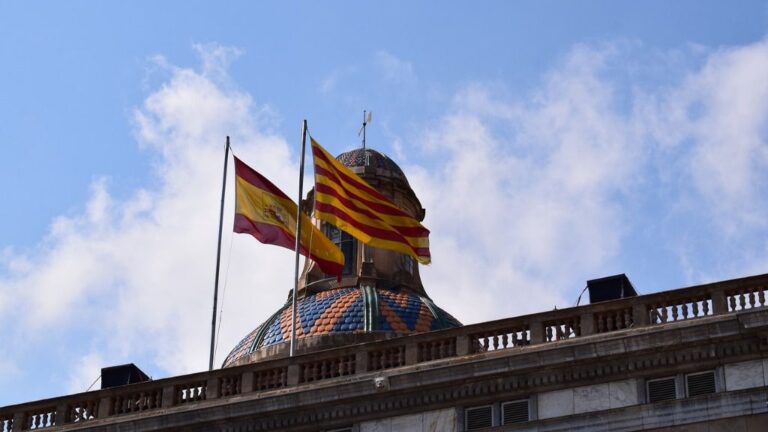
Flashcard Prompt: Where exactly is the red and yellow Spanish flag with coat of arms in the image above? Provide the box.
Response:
[235,157,344,277]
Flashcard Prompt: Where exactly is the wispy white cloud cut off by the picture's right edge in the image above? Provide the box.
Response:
[641,40,768,234]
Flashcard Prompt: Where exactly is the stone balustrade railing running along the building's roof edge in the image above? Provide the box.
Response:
[0,274,768,432]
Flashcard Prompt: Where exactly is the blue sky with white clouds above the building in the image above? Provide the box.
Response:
[0,1,768,405]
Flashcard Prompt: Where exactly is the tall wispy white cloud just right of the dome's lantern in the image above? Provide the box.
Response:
[409,45,639,322]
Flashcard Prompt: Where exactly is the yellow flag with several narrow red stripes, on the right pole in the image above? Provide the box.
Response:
[310,137,430,264]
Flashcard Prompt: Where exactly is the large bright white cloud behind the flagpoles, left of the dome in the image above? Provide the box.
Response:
[0,45,296,389]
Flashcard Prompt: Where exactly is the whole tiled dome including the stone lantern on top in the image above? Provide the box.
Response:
[223,148,461,367]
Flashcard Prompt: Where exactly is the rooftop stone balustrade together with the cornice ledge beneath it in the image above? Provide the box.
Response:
[0,274,768,432]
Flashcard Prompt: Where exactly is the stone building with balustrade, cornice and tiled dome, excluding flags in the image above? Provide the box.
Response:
[0,149,768,432]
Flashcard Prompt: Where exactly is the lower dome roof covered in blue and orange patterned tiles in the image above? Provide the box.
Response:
[223,287,461,367]
